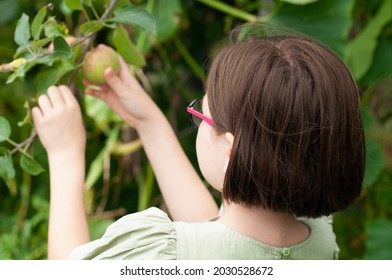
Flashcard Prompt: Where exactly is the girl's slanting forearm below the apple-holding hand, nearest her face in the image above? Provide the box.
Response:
[138,108,218,222]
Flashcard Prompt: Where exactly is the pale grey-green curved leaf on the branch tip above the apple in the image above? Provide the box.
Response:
[107,6,156,35]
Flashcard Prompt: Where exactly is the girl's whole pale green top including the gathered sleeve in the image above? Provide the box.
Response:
[70,208,339,260]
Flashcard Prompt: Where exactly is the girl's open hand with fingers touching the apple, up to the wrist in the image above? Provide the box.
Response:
[84,57,156,128]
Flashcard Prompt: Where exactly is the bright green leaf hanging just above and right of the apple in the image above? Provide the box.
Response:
[113,25,146,67]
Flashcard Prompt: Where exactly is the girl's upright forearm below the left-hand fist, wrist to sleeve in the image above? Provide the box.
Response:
[48,150,90,259]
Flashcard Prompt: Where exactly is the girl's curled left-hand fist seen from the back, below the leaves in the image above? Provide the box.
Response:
[32,86,86,156]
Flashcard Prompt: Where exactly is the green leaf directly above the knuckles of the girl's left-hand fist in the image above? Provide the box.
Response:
[34,61,76,93]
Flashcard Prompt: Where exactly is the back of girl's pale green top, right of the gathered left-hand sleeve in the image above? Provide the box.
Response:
[174,217,339,260]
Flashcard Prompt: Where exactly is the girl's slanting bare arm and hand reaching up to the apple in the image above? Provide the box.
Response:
[86,58,218,222]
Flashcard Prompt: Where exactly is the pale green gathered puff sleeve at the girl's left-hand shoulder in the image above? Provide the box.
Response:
[70,208,176,260]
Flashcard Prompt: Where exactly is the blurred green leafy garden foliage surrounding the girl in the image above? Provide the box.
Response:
[0,0,392,259]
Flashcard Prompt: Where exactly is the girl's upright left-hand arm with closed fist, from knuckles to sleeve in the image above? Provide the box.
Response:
[32,86,90,259]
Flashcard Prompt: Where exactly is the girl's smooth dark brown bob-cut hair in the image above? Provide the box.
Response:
[206,25,365,218]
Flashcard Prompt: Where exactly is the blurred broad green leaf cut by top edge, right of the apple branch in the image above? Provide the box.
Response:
[153,0,182,43]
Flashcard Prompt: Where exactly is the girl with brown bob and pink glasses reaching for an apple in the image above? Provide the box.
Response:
[32,26,364,259]
